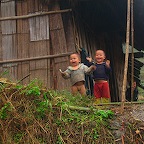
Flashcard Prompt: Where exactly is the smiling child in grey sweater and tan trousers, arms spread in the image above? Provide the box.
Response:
[60,53,93,95]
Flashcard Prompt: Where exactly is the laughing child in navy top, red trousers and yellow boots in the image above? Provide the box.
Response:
[87,50,111,104]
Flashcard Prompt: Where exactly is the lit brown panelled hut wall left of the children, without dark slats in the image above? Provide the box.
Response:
[0,0,75,89]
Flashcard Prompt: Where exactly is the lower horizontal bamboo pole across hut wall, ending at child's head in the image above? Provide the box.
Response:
[0,52,73,64]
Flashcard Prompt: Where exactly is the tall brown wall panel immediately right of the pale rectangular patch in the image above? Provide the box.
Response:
[49,3,70,90]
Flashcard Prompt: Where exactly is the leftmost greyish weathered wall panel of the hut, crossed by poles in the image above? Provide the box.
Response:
[1,1,17,80]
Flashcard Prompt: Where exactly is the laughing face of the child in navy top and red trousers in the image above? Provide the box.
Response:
[95,50,105,63]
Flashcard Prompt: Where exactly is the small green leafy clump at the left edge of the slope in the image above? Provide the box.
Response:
[0,102,11,120]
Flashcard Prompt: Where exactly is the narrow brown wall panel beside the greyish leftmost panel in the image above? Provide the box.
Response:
[17,1,30,84]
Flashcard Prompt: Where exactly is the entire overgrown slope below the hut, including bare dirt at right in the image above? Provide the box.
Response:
[0,80,144,144]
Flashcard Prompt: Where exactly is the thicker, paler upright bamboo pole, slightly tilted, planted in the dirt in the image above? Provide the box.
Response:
[121,0,130,112]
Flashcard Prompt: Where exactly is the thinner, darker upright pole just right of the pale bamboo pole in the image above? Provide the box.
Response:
[131,0,134,101]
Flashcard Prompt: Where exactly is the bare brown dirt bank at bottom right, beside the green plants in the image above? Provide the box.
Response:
[111,104,144,144]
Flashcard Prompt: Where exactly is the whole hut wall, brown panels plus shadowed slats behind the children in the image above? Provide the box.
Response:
[0,0,124,101]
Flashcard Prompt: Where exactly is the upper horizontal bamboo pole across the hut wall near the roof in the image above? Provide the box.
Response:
[0,9,72,21]
